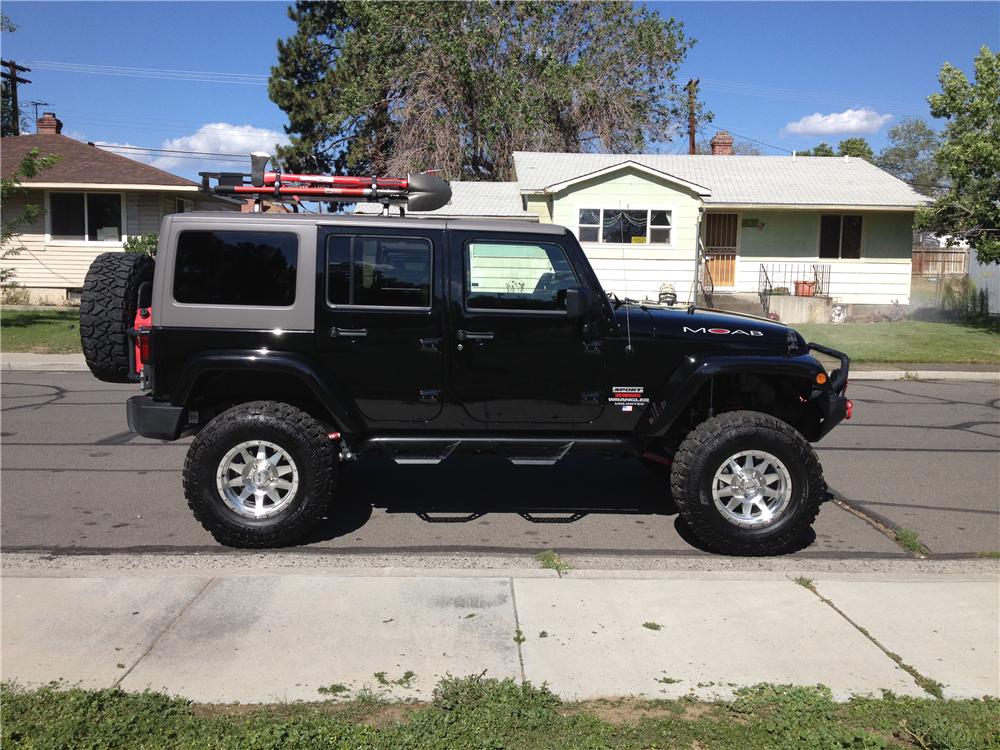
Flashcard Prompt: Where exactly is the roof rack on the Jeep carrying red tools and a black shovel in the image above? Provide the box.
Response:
[198,152,451,216]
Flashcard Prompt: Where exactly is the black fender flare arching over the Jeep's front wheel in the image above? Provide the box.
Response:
[640,352,823,438]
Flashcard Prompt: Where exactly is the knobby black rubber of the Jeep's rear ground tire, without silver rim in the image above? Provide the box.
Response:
[183,401,337,548]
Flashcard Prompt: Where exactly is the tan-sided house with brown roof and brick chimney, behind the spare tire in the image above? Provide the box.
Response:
[0,112,240,304]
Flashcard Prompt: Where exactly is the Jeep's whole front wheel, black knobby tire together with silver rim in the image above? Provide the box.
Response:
[671,411,823,555]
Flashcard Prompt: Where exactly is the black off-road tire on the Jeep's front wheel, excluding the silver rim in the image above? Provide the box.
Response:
[671,411,825,556]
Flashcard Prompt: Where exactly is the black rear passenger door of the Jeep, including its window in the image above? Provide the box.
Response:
[316,226,445,426]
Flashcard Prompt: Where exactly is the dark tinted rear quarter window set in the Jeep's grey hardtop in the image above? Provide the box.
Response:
[174,231,298,307]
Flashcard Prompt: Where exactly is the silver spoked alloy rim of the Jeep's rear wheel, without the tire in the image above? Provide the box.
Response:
[215,440,299,519]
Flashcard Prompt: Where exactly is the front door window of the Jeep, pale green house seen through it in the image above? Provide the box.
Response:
[466,242,580,310]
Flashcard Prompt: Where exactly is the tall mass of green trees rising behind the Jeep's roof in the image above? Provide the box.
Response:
[269,0,709,180]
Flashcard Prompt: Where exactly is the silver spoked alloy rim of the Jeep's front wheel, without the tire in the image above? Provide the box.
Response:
[712,451,792,529]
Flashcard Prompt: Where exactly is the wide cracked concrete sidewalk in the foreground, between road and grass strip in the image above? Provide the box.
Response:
[2,568,1000,702]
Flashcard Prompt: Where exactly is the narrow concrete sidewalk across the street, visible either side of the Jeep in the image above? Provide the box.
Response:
[0,352,1000,382]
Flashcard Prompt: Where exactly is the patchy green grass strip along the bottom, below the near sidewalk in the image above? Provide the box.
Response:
[0,677,1000,750]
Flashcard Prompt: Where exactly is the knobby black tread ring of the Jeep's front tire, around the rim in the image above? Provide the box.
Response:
[671,411,825,556]
